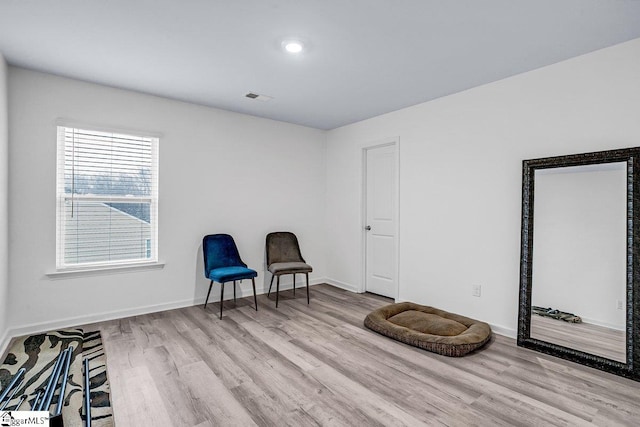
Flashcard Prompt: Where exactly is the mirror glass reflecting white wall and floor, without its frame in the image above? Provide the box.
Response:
[531,162,627,363]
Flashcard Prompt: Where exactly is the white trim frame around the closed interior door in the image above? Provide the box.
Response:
[358,136,400,301]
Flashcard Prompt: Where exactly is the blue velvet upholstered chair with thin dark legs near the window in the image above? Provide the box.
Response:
[202,234,258,319]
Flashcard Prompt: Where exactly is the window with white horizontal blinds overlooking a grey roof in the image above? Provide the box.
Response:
[56,126,158,269]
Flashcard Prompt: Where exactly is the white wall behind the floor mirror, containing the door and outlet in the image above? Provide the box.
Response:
[326,39,640,335]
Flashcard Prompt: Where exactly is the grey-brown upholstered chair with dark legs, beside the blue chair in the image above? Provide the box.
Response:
[267,231,313,308]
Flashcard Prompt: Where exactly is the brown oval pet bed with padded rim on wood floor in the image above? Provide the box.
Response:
[364,302,491,357]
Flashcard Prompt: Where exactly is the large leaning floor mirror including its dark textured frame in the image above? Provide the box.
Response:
[518,148,640,380]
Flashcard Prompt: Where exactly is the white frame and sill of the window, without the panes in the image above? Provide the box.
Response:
[55,120,164,270]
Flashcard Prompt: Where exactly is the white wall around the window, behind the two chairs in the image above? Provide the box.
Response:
[9,67,325,333]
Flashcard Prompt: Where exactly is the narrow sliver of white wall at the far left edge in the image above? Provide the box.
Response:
[0,53,9,357]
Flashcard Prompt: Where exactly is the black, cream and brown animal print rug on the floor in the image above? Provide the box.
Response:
[0,329,114,427]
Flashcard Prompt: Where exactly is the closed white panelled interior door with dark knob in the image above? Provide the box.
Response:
[365,145,398,298]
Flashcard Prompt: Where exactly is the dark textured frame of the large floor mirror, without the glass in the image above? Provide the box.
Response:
[518,147,640,381]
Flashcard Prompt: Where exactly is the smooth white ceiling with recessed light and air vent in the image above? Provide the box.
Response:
[0,0,640,129]
